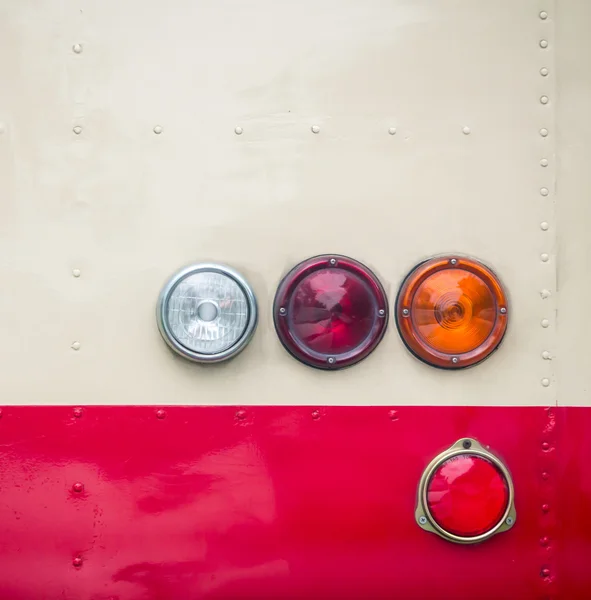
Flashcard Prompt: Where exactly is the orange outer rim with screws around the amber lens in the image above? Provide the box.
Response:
[394,254,510,370]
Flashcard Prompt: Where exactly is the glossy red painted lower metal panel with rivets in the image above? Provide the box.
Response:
[0,406,591,600]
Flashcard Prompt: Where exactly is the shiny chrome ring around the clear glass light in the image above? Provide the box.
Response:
[156,263,258,363]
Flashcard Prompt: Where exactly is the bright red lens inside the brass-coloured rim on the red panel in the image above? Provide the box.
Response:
[427,453,509,538]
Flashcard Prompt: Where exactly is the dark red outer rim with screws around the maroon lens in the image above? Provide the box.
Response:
[273,254,389,371]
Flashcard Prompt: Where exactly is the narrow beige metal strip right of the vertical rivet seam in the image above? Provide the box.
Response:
[555,0,591,406]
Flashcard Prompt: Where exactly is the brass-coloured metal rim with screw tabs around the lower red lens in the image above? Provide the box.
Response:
[415,438,516,544]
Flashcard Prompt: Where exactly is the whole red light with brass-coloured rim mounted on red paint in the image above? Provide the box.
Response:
[417,440,515,543]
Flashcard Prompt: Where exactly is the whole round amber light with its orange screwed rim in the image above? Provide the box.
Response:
[396,257,507,369]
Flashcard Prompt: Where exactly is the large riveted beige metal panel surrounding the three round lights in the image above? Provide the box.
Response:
[0,0,556,405]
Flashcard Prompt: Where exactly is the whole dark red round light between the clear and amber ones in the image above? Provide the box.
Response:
[273,255,388,369]
